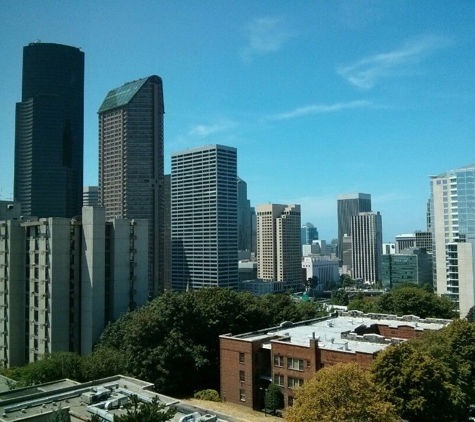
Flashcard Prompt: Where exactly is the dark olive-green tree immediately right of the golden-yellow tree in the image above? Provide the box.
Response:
[372,342,460,422]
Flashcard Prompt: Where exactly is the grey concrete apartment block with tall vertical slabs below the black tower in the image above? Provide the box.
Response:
[0,207,148,367]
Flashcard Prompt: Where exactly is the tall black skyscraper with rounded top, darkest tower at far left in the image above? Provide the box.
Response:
[14,42,84,218]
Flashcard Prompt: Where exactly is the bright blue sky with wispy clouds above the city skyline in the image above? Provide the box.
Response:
[0,0,475,241]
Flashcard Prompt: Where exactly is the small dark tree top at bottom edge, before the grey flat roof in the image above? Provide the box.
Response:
[114,395,176,422]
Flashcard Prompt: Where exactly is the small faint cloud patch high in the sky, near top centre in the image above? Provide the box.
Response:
[241,16,292,61]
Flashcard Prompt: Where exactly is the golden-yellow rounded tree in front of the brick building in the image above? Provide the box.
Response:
[285,364,400,422]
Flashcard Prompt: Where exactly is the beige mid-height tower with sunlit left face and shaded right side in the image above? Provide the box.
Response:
[256,204,302,289]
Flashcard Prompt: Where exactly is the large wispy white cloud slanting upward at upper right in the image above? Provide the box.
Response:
[337,36,451,89]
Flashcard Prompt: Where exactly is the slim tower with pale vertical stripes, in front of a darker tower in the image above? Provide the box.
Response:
[351,212,383,283]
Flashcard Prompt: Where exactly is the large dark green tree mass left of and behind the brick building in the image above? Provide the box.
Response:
[95,288,323,394]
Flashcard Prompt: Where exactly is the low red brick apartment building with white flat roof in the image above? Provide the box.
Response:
[220,311,450,409]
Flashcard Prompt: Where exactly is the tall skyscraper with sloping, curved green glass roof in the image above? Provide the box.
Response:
[98,75,165,295]
